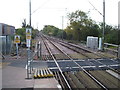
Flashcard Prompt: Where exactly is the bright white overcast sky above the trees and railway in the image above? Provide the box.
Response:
[0,0,120,29]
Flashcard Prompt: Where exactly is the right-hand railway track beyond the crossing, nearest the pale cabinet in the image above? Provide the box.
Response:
[50,35,116,59]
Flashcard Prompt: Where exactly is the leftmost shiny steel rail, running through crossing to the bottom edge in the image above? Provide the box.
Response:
[41,37,72,90]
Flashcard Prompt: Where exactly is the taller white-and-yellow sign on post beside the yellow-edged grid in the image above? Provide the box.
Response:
[26,28,32,79]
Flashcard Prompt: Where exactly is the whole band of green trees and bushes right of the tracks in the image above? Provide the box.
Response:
[42,10,120,44]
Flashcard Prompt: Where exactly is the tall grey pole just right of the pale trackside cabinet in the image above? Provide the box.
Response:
[102,0,105,50]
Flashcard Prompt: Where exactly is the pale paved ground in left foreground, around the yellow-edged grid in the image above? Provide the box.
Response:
[0,59,61,90]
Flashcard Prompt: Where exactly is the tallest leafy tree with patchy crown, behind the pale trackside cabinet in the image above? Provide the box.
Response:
[66,10,99,41]
